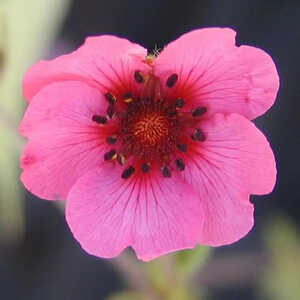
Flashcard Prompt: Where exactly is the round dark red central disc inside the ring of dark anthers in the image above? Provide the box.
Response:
[120,99,180,164]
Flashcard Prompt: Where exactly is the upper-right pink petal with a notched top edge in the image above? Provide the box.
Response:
[155,28,279,119]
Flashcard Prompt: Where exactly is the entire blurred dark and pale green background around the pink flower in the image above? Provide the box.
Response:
[0,0,300,300]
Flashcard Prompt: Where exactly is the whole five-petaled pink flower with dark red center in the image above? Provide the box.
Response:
[20,28,279,260]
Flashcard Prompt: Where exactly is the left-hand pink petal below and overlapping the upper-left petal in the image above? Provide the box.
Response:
[20,81,111,200]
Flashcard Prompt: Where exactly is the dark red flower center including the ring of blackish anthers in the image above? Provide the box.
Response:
[92,71,206,179]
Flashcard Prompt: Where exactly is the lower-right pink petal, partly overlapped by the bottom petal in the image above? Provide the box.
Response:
[184,114,276,246]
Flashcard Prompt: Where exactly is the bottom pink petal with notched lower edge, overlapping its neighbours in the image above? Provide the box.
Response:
[66,165,203,261]
